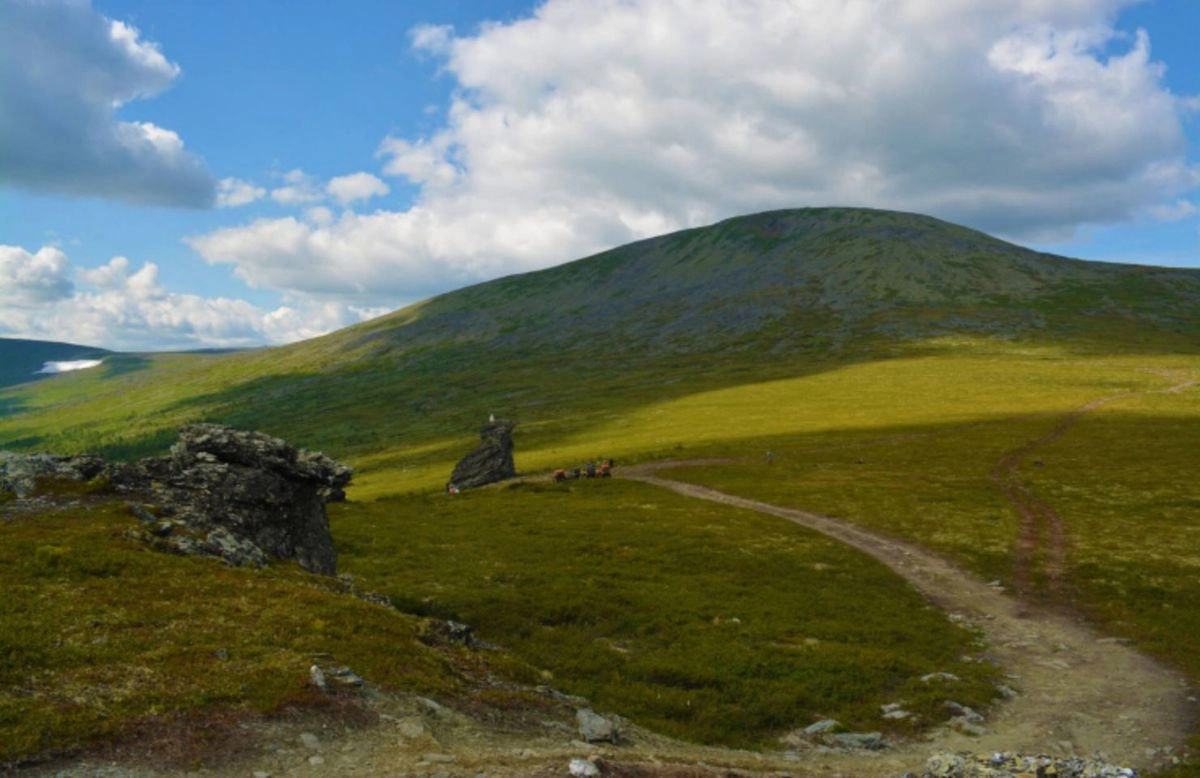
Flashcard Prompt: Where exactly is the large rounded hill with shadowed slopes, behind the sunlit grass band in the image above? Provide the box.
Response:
[0,208,1200,457]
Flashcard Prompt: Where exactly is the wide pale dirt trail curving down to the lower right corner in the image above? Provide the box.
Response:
[622,463,1195,774]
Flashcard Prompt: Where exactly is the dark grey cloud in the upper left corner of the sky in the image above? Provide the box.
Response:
[0,0,215,208]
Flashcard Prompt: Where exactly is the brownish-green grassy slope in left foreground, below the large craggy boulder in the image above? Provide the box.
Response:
[0,497,536,766]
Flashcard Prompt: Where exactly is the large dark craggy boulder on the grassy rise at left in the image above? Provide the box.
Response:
[110,424,352,575]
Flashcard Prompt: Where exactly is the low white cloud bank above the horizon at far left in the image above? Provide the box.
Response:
[0,246,382,351]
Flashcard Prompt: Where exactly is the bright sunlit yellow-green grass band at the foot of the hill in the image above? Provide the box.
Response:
[355,339,1170,498]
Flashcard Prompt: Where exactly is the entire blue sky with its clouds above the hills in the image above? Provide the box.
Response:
[0,0,1200,349]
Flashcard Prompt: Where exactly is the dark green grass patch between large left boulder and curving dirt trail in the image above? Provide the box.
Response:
[332,479,998,747]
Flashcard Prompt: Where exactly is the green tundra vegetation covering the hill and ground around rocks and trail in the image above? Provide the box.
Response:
[0,209,1200,770]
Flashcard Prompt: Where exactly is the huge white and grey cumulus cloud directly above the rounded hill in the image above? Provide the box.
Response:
[190,0,1196,299]
